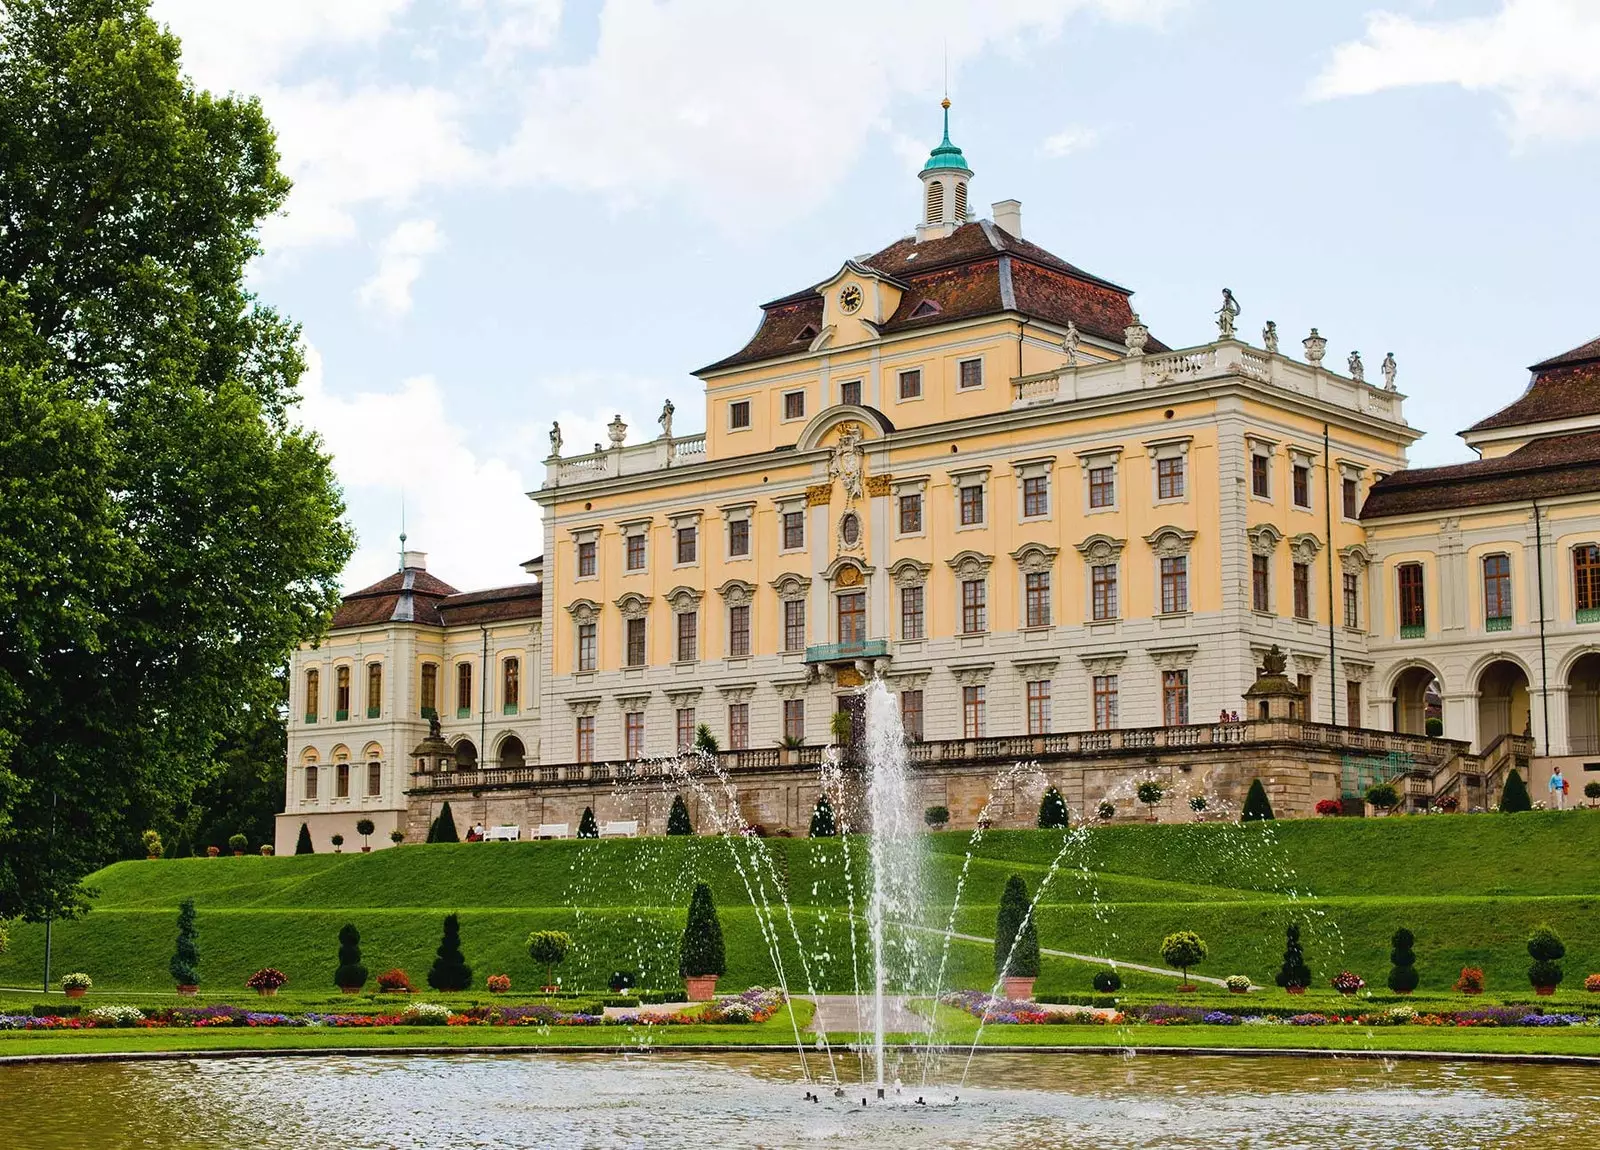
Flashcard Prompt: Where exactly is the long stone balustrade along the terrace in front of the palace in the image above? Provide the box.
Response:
[403,718,1467,792]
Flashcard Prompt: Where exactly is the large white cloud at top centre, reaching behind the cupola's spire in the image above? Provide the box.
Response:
[502,0,1182,229]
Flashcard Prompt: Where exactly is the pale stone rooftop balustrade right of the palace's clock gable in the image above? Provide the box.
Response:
[1011,339,1405,424]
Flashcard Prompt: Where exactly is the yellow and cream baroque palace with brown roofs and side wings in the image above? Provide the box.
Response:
[278,106,1600,851]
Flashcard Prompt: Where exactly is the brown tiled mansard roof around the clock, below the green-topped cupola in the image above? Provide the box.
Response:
[701,221,1166,371]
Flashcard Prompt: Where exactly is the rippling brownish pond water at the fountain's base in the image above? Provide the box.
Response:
[0,1054,1600,1150]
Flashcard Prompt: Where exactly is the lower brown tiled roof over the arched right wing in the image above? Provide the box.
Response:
[1362,430,1600,520]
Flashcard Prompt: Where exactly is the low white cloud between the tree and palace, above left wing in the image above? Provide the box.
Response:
[299,349,544,590]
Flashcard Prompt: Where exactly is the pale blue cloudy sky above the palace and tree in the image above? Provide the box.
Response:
[152,0,1600,590]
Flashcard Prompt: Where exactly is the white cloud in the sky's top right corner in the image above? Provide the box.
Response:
[1309,0,1600,144]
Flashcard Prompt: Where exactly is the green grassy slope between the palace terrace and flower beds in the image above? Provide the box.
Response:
[9,811,1600,998]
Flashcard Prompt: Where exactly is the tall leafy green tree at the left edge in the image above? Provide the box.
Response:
[0,0,352,918]
